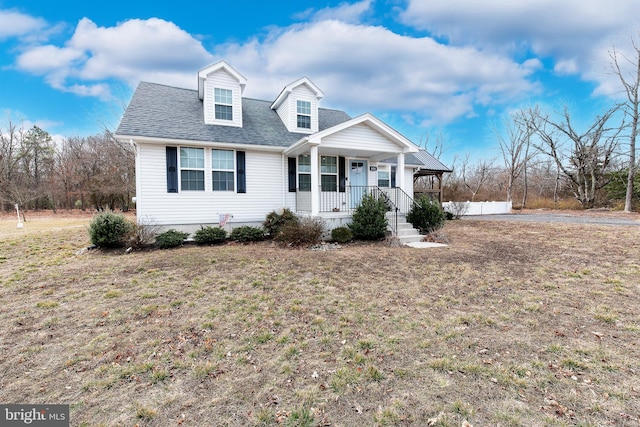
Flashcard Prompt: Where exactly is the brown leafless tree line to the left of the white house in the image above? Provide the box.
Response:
[0,118,135,211]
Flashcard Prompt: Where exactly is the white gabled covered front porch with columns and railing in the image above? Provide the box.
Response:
[284,114,419,216]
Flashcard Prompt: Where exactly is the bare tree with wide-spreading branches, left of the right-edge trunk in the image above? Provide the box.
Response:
[526,106,622,208]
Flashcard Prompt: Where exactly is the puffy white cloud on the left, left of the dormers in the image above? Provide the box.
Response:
[16,18,212,98]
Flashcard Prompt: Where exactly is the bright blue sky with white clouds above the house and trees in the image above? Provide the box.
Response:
[0,0,640,166]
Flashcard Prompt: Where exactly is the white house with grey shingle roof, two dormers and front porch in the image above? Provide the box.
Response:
[116,61,448,241]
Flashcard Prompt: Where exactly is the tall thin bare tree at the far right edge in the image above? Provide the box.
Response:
[609,38,640,212]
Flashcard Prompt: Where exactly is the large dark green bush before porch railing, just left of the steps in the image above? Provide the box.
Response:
[348,194,388,240]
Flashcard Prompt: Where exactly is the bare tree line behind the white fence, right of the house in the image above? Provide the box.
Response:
[437,35,640,212]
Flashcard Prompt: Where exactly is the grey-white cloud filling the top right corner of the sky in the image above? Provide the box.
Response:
[401,0,640,83]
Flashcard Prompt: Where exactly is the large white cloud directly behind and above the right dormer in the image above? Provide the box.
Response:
[218,20,536,121]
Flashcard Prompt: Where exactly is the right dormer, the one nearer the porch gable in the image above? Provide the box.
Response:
[271,77,324,134]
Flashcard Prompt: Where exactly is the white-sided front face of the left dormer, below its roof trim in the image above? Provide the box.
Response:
[202,69,242,127]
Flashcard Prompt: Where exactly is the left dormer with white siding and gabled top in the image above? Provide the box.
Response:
[198,61,247,127]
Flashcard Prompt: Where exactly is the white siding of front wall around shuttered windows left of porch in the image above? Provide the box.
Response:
[136,143,283,226]
